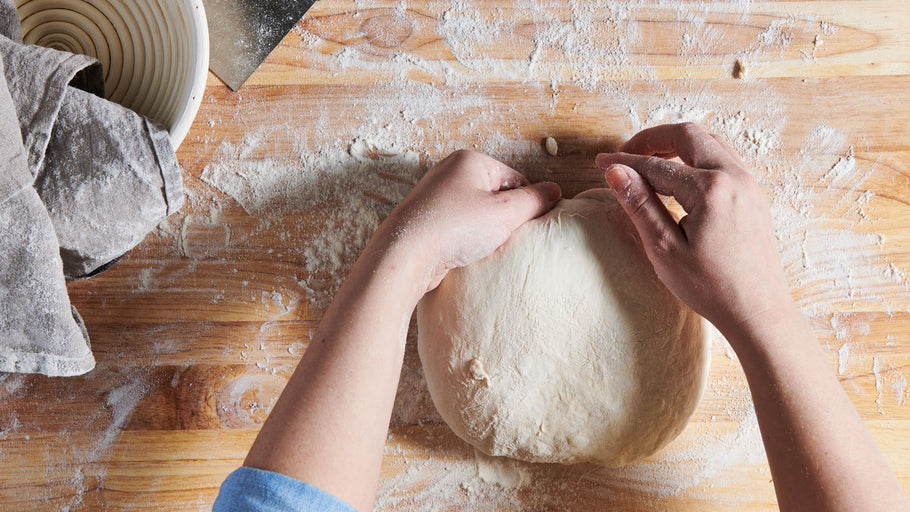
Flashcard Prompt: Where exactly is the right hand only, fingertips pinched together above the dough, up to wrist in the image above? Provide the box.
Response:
[596,123,795,337]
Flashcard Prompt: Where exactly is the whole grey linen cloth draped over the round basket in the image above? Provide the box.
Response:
[0,0,184,376]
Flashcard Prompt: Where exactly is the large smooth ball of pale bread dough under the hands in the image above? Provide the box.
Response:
[417,189,710,466]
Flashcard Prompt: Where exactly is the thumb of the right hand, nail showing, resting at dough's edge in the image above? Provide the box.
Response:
[604,164,685,255]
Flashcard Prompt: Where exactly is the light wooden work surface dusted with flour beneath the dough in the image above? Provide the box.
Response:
[0,0,910,511]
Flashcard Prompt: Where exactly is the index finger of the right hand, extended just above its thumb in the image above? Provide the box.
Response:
[594,153,700,211]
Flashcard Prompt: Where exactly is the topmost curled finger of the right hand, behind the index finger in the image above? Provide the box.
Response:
[620,123,730,169]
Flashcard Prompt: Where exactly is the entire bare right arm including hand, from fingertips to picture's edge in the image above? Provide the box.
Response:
[596,123,910,512]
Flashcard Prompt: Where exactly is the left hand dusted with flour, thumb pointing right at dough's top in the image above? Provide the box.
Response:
[380,150,561,291]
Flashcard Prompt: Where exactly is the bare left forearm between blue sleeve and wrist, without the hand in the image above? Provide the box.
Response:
[244,229,426,510]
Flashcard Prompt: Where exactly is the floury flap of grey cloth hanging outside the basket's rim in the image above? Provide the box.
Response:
[35,87,184,279]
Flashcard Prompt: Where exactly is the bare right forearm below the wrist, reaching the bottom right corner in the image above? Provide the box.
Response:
[725,306,910,511]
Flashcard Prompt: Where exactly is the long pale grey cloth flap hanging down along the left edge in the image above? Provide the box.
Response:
[0,52,95,376]
